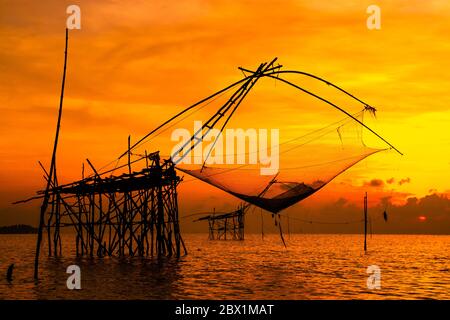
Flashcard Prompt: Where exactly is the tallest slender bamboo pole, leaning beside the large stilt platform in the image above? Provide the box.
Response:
[34,28,69,279]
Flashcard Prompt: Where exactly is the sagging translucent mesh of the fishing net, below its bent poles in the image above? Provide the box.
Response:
[178,111,383,213]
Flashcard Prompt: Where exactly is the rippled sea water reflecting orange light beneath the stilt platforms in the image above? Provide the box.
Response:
[0,234,450,299]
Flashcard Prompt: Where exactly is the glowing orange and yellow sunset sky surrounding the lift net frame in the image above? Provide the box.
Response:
[0,0,450,230]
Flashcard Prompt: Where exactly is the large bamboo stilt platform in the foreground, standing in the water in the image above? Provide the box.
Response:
[39,152,187,257]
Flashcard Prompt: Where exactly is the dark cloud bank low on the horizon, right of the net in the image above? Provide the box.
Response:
[262,193,450,234]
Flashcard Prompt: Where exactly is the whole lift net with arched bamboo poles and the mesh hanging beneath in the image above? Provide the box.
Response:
[102,62,392,213]
